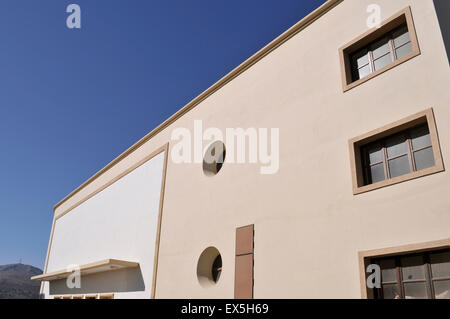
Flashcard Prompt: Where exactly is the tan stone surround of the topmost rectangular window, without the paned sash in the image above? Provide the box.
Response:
[339,7,420,92]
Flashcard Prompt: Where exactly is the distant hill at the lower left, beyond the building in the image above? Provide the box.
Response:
[0,264,42,299]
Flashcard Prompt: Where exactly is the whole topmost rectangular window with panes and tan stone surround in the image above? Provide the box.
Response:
[339,7,420,91]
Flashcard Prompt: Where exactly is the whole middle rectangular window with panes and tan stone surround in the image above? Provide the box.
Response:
[349,109,444,194]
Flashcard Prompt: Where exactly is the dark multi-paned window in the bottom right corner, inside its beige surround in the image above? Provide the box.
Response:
[370,249,450,299]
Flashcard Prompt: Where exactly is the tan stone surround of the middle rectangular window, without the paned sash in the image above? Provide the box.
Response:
[349,108,444,195]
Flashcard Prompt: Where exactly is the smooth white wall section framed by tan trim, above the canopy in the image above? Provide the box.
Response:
[44,153,164,298]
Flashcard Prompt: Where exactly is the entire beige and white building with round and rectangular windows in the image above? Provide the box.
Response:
[34,0,450,298]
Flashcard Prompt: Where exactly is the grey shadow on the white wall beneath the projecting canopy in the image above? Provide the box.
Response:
[50,267,145,295]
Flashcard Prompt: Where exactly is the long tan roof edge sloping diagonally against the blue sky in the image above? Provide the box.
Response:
[53,0,344,212]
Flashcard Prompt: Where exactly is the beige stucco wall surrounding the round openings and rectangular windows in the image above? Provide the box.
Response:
[50,0,450,298]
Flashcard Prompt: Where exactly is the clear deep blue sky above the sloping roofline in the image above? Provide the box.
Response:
[0,0,325,269]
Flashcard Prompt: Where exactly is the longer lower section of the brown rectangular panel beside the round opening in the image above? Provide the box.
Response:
[234,254,253,299]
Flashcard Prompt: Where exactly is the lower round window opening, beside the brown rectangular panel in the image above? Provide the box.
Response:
[197,247,222,287]
